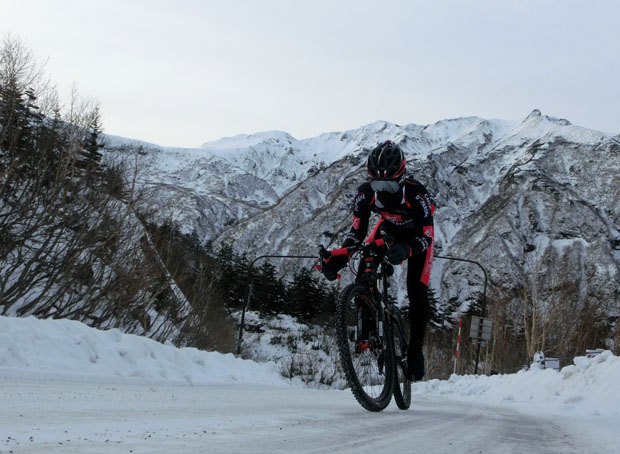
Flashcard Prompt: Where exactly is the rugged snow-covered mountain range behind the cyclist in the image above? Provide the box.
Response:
[106,110,620,320]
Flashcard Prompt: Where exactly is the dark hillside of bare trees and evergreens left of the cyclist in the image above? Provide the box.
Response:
[0,39,335,351]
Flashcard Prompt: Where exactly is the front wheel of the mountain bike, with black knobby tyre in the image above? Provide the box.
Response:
[336,284,395,411]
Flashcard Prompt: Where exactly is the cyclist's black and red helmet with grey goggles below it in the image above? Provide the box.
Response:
[366,140,407,192]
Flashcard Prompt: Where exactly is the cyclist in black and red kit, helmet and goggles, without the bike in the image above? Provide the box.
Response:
[322,140,435,381]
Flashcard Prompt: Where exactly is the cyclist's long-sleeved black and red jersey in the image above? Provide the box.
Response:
[347,178,435,253]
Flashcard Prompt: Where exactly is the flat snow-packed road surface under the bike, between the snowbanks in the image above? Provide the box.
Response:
[0,381,599,454]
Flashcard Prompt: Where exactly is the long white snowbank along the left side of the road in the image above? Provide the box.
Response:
[0,316,288,385]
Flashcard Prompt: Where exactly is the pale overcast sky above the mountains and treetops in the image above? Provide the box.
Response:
[0,0,620,147]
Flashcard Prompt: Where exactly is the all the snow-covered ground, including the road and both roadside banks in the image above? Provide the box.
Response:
[0,317,620,454]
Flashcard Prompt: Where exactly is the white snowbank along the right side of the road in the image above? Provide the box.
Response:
[413,351,620,420]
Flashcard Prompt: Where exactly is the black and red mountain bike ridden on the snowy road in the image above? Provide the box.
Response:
[319,239,411,411]
